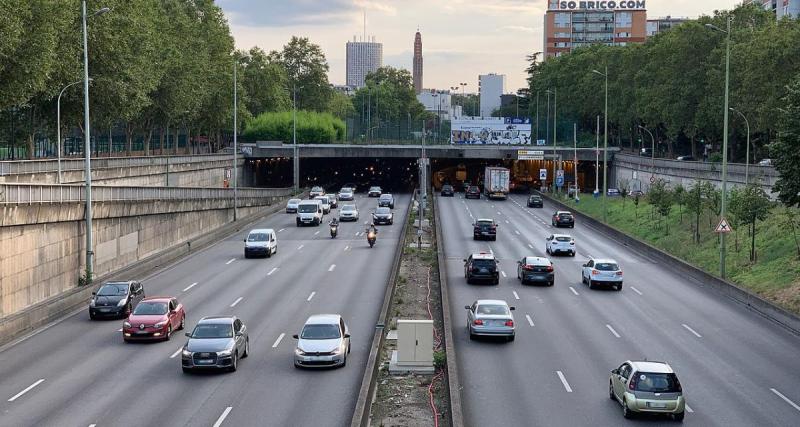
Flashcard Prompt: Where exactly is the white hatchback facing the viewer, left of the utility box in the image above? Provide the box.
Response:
[292,314,350,368]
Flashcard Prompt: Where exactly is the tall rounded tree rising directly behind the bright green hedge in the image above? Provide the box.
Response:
[267,36,333,111]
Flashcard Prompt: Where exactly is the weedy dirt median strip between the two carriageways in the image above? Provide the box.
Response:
[370,202,451,427]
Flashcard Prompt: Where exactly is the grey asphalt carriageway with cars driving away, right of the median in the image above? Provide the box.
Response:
[437,194,800,426]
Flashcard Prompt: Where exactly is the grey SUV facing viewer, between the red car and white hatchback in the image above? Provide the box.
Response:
[181,316,250,373]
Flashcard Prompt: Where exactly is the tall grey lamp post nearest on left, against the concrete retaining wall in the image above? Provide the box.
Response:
[81,0,111,283]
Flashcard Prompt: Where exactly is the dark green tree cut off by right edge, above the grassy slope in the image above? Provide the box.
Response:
[770,74,800,207]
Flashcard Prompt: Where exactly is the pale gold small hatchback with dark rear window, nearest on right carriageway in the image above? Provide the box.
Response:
[608,360,686,421]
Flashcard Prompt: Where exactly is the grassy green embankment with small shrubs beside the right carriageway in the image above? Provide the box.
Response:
[556,189,800,314]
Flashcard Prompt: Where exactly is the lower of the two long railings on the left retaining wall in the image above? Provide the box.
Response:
[0,184,292,204]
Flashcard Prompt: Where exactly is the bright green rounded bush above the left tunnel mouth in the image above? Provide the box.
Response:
[242,111,346,144]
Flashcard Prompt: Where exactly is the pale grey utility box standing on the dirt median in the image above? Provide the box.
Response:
[389,320,434,374]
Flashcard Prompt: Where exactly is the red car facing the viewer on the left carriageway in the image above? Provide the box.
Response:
[122,297,186,342]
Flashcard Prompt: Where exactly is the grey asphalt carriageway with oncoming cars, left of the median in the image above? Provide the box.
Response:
[0,194,409,427]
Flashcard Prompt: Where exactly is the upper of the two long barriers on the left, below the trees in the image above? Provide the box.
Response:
[0,154,238,176]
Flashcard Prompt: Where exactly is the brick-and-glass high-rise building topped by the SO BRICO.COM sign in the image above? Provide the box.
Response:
[544,0,647,58]
